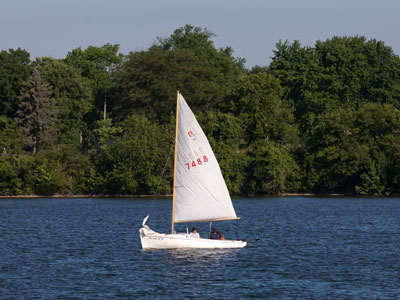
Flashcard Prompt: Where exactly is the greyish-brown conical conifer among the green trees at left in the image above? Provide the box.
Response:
[18,70,57,153]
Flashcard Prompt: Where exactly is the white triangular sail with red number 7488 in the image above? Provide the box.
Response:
[173,94,237,223]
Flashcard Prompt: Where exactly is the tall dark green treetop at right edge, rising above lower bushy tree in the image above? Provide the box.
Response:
[315,36,400,107]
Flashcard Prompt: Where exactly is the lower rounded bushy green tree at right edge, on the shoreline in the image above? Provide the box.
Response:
[307,103,400,195]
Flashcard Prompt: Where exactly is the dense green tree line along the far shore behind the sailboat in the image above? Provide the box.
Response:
[0,25,400,195]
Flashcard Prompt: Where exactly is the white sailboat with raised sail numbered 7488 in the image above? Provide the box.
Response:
[139,91,247,249]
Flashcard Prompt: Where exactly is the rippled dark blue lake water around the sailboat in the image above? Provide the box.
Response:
[0,197,400,300]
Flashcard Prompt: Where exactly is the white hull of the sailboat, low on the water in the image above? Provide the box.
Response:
[139,225,247,249]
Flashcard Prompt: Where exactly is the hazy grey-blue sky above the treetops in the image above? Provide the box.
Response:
[0,0,400,68]
